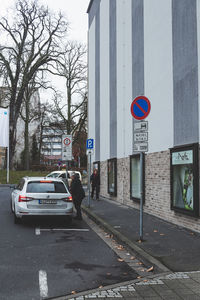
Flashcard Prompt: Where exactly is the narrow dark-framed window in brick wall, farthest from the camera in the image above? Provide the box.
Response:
[108,158,117,196]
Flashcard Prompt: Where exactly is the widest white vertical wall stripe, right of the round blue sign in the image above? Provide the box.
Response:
[144,0,173,152]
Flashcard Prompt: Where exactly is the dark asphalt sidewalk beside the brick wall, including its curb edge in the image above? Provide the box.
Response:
[83,199,200,272]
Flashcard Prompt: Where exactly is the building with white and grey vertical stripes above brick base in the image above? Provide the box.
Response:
[88,0,200,232]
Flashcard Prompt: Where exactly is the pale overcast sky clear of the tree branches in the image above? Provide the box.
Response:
[0,0,90,43]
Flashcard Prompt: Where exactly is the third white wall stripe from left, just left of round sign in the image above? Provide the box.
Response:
[116,0,132,158]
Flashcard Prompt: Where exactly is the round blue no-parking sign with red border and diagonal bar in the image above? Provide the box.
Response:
[131,96,151,120]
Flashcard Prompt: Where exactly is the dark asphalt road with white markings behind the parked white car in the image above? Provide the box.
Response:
[0,187,137,300]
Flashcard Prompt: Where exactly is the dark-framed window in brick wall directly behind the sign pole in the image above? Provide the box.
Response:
[130,154,145,201]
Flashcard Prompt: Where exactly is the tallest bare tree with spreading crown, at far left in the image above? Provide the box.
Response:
[0,0,68,166]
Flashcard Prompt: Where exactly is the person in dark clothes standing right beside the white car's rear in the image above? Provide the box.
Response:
[70,173,85,220]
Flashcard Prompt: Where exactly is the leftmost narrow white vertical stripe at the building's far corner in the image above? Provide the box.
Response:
[88,18,95,161]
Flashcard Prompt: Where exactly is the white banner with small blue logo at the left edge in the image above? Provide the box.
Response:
[0,108,9,147]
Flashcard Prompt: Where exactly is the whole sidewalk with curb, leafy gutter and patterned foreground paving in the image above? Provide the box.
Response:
[49,199,200,300]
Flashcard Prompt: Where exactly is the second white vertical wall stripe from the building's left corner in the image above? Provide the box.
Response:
[100,0,110,161]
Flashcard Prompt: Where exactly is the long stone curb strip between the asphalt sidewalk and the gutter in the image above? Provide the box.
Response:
[82,205,172,272]
